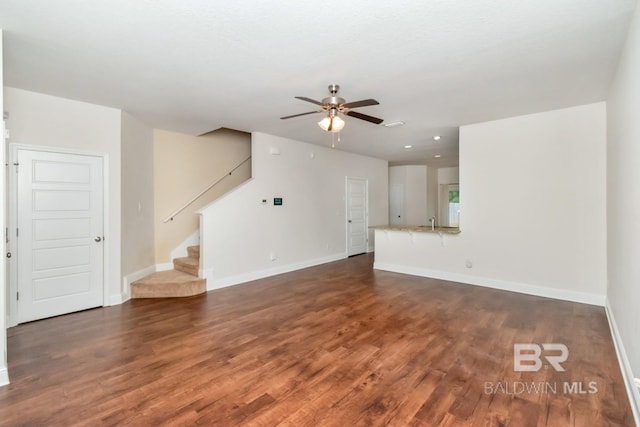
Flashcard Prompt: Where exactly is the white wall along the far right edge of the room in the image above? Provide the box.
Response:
[607,0,640,416]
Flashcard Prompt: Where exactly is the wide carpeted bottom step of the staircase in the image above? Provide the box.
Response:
[131,270,207,298]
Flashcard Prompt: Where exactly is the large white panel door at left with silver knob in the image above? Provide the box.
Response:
[16,149,104,323]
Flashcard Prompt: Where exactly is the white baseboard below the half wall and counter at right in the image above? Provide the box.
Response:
[373,262,605,307]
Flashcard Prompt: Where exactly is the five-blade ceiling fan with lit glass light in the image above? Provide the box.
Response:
[280,84,383,132]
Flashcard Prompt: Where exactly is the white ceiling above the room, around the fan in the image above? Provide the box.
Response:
[0,0,636,166]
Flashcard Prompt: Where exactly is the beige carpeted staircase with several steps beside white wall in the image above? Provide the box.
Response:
[131,246,207,298]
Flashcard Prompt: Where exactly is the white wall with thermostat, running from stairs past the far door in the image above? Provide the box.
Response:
[200,133,388,288]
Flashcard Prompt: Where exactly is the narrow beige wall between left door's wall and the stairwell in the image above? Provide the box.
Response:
[121,112,155,292]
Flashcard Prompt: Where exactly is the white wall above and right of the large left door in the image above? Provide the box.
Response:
[5,87,121,305]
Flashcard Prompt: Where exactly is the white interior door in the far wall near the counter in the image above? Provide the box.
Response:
[347,178,369,256]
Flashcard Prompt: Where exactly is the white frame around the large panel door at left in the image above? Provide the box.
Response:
[7,142,111,327]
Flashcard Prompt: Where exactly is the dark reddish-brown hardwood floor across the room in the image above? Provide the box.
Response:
[0,255,633,426]
